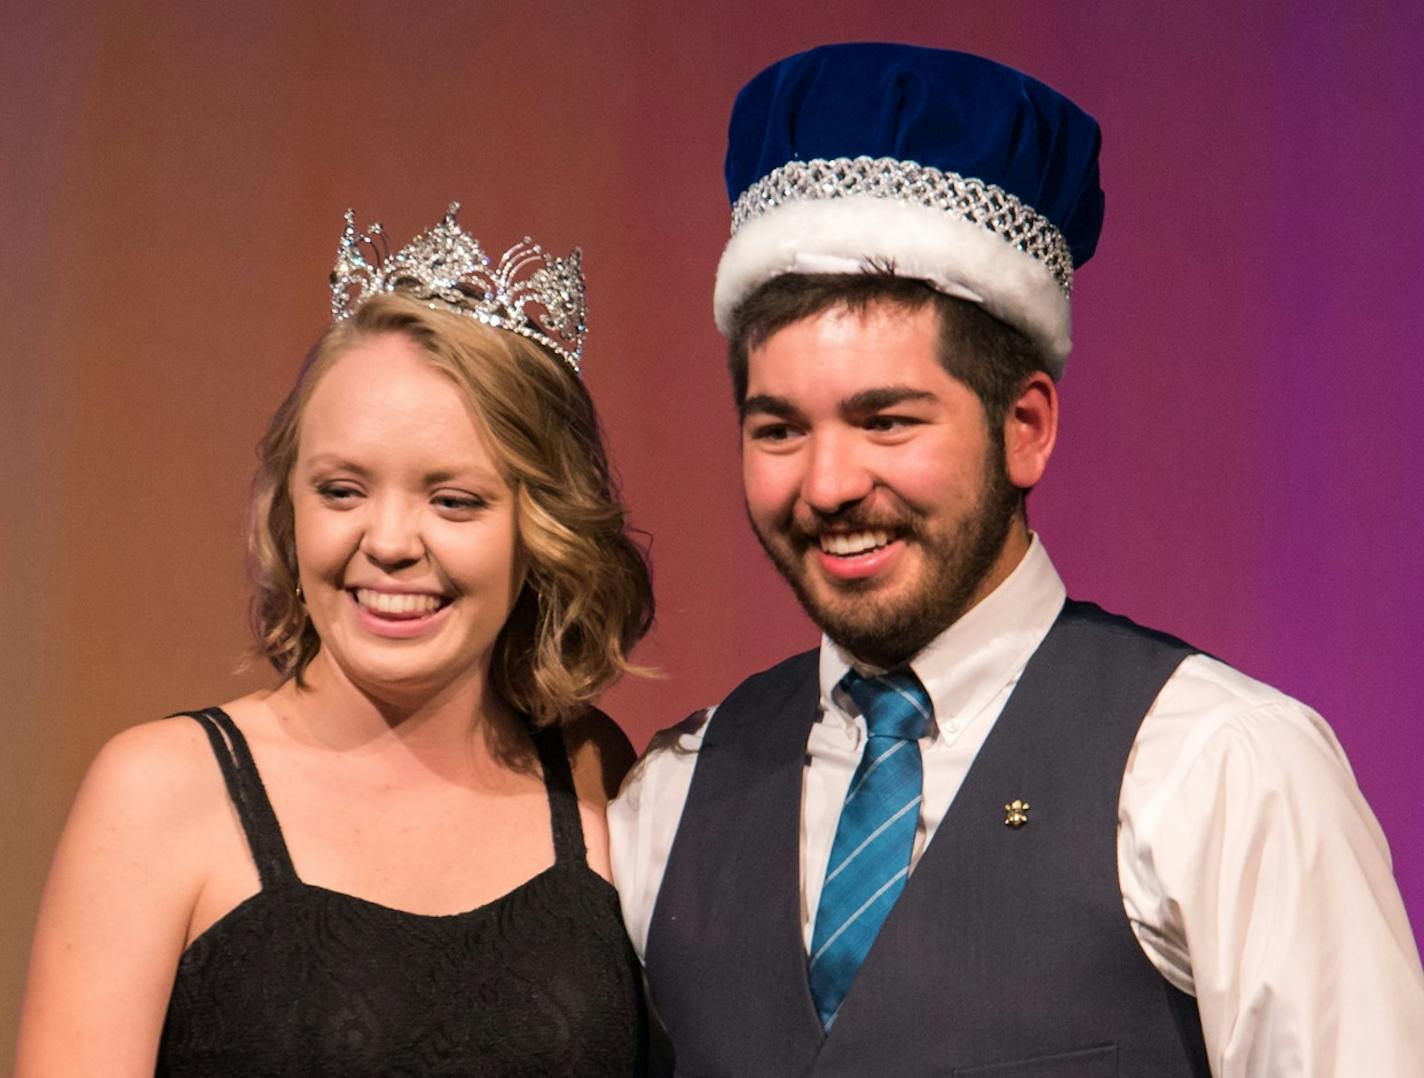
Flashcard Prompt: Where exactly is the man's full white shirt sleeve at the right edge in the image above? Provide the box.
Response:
[1119,656,1424,1078]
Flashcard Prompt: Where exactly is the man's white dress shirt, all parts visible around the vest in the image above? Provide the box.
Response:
[608,538,1424,1078]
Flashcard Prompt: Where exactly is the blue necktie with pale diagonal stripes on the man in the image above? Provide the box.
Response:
[810,669,933,1030]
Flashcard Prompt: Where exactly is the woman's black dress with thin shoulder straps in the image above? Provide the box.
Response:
[157,708,645,1078]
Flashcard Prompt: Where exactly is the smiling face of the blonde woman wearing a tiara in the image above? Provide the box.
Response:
[289,333,524,699]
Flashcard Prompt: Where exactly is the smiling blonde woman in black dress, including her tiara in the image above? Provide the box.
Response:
[19,205,652,1078]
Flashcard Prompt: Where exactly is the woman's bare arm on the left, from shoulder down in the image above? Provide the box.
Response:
[16,719,221,1078]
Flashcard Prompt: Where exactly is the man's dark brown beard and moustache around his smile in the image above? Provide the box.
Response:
[752,449,1022,669]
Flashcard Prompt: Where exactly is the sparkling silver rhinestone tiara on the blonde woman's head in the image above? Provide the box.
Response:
[332,202,588,375]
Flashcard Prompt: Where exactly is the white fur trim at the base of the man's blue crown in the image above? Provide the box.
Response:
[712,195,1072,379]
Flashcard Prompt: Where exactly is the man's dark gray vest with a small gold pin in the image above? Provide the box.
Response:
[646,601,1209,1078]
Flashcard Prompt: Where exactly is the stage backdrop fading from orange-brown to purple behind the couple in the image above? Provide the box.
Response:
[0,0,1424,1059]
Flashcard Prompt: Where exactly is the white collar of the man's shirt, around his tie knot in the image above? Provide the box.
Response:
[820,535,1067,732]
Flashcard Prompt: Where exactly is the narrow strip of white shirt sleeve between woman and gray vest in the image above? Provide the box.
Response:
[608,708,713,960]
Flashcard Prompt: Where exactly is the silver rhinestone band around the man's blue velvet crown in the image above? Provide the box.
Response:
[732,157,1072,295]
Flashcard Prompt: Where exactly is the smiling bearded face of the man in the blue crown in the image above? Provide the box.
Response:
[742,302,1027,666]
